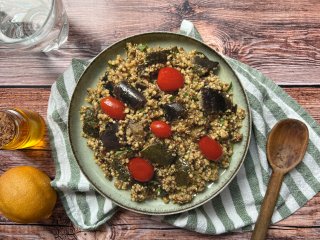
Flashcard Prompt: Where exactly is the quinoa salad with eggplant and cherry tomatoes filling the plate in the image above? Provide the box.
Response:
[80,43,246,204]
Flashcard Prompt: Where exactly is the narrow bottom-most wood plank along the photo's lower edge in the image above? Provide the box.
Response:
[0,221,320,240]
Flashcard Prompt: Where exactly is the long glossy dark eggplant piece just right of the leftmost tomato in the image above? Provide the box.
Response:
[113,81,147,109]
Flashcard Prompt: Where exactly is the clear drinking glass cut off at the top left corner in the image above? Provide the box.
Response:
[0,0,69,52]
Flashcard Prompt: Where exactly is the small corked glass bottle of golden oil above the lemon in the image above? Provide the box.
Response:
[0,108,45,150]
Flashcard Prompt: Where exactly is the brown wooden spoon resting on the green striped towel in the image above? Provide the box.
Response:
[251,119,309,240]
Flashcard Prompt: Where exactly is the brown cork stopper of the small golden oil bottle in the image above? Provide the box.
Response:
[0,111,16,149]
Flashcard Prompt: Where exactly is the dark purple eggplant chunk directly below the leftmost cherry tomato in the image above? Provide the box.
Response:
[100,123,122,151]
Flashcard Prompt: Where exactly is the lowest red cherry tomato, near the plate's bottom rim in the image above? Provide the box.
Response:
[128,158,154,182]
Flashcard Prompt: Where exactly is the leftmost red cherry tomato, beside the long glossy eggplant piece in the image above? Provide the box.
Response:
[100,97,126,120]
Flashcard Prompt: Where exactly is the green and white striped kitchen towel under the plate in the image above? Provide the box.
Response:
[48,20,320,234]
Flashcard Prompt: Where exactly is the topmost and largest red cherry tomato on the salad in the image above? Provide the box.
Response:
[157,67,184,92]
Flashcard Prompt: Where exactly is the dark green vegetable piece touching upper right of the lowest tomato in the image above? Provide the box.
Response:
[141,143,176,166]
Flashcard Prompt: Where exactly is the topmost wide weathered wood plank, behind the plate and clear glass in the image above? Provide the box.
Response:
[0,0,320,85]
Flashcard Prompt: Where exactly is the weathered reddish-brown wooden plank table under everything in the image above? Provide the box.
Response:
[0,0,320,239]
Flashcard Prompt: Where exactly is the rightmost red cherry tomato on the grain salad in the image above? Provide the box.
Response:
[199,136,223,161]
